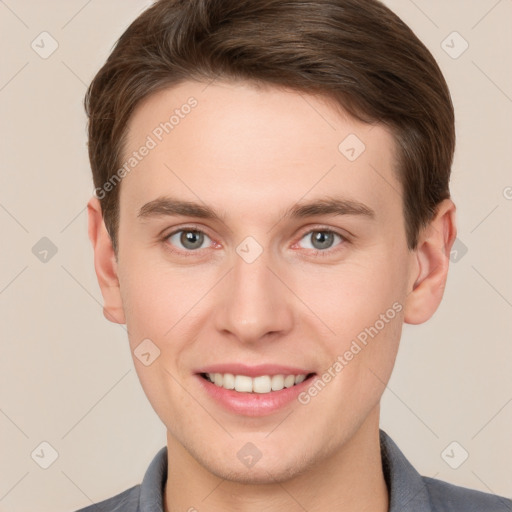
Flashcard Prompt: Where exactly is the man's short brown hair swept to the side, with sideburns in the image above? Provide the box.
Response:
[85,0,455,249]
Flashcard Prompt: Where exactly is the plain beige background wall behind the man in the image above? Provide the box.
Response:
[0,0,512,512]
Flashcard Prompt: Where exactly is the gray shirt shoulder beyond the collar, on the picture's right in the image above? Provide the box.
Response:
[422,477,512,512]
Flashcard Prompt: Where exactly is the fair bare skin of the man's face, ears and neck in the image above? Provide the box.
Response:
[88,82,456,512]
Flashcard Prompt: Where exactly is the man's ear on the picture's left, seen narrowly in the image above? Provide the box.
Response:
[87,197,126,324]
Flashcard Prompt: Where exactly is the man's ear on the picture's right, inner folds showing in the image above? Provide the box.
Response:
[404,199,457,324]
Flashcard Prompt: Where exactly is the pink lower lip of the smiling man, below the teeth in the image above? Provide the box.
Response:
[196,375,315,416]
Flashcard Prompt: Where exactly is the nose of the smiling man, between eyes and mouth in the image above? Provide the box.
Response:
[214,243,294,344]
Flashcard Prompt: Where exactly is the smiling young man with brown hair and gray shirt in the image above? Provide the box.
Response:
[76,0,512,512]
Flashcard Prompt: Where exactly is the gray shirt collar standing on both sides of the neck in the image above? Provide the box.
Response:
[138,430,432,512]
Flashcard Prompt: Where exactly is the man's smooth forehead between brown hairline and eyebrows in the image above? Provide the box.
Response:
[121,82,400,222]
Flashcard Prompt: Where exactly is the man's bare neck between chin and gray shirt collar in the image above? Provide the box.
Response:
[164,406,389,512]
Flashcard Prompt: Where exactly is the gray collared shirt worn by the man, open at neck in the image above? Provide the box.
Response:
[76,430,512,512]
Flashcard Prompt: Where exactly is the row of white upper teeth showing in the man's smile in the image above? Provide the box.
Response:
[207,373,306,393]
